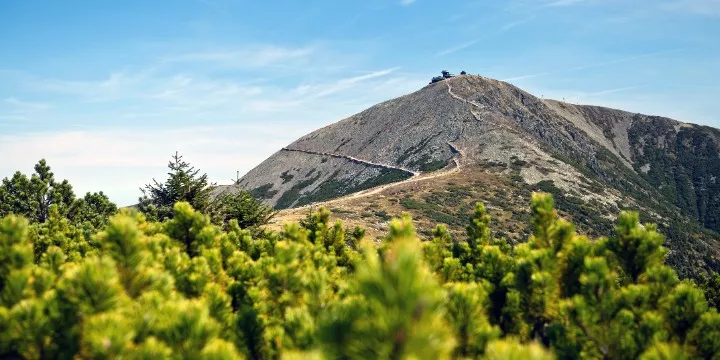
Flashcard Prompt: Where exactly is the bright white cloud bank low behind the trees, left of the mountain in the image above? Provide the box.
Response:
[0,125,302,205]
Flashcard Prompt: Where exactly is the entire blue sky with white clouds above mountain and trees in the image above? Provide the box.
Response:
[0,0,720,205]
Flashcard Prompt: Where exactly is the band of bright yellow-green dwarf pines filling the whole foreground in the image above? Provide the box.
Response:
[0,190,720,360]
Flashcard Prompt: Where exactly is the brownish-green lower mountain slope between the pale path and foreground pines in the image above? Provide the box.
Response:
[269,166,720,277]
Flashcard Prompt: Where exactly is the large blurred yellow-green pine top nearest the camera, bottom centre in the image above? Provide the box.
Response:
[321,217,455,359]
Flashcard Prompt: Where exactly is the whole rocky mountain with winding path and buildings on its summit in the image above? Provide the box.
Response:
[221,75,720,276]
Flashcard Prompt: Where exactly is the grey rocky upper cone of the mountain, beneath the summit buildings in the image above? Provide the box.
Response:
[231,76,612,208]
